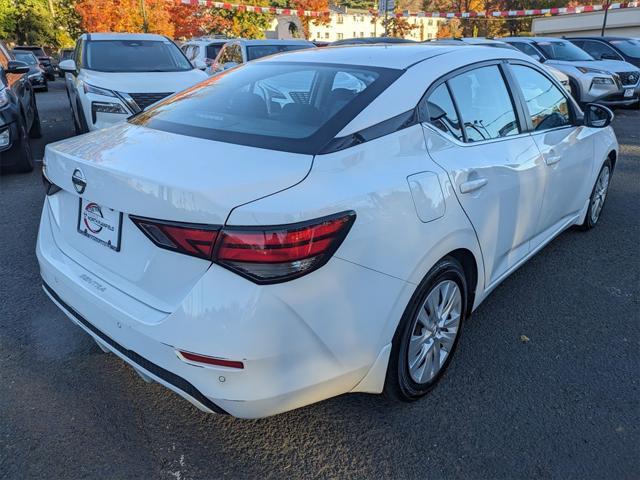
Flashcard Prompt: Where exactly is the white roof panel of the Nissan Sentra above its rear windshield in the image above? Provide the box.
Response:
[254,43,464,70]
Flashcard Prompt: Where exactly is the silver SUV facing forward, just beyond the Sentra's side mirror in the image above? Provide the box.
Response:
[501,37,640,107]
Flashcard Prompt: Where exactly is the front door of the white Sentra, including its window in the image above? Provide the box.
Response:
[510,62,594,248]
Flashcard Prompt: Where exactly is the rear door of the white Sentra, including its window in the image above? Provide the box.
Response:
[421,62,545,285]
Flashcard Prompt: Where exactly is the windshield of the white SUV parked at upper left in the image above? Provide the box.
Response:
[84,40,193,72]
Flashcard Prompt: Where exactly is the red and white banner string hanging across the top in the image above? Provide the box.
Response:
[179,0,640,18]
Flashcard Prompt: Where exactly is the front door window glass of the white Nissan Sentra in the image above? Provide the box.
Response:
[511,65,571,131]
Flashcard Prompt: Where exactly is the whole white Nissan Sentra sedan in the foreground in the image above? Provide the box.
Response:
[37,45,618,418]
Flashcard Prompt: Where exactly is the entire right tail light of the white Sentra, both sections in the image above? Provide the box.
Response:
[131,211,356,284]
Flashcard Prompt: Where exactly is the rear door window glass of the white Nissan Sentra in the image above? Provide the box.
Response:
[448,65,520,142]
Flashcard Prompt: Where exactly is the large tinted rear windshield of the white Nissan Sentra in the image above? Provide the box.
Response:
[130,62,402,154]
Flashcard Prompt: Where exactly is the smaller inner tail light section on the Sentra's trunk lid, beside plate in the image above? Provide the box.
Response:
[130,215,220,260]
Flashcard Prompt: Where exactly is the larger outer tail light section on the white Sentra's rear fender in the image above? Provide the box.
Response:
[214,212,356,284]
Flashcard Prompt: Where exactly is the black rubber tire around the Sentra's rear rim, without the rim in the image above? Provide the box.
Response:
[385,257,468,401]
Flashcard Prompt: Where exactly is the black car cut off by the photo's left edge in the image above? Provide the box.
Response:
[0,41,41,172]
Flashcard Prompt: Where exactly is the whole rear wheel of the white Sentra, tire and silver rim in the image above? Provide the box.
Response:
[384,257,468,402]
